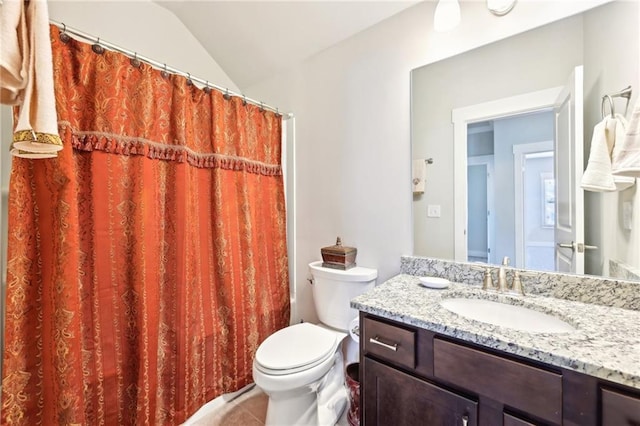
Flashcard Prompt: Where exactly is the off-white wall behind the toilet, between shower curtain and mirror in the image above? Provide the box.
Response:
[245,1,603,321]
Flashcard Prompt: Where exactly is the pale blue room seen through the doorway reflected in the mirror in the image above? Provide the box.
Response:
[467,111,555,271]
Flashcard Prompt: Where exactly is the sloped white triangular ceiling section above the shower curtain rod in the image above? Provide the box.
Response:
[154,0,417,89]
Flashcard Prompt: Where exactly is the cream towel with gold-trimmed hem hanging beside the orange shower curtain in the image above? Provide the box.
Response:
[0,0,62,158]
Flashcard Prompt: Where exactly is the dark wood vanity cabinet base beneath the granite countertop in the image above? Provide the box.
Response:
[360,313,640,426]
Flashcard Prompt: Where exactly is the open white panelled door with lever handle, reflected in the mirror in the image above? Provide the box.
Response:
[554,66,585,274]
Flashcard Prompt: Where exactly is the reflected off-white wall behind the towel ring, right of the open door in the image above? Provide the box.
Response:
[584,1,640,275]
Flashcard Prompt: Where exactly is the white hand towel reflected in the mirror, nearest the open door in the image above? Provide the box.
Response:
[580,117,616,192]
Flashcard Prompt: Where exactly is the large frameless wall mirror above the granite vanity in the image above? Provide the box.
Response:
[411,1,640,279]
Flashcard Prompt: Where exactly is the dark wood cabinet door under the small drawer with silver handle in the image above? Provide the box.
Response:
[362,357,478,426]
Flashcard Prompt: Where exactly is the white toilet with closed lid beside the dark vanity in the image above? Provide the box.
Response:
[253,261,378,426]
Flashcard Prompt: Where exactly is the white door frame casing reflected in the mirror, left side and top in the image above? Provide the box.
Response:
[451,86,564,262]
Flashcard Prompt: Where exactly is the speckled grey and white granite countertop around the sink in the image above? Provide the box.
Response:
[351,274,640,389]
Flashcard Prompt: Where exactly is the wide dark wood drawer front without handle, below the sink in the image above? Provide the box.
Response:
[433,338,562,424]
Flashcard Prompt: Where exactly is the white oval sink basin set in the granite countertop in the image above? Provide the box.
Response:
[440,298,576,333]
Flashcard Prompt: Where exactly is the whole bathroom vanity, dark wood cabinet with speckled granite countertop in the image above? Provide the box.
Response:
[352,260,640,426]
